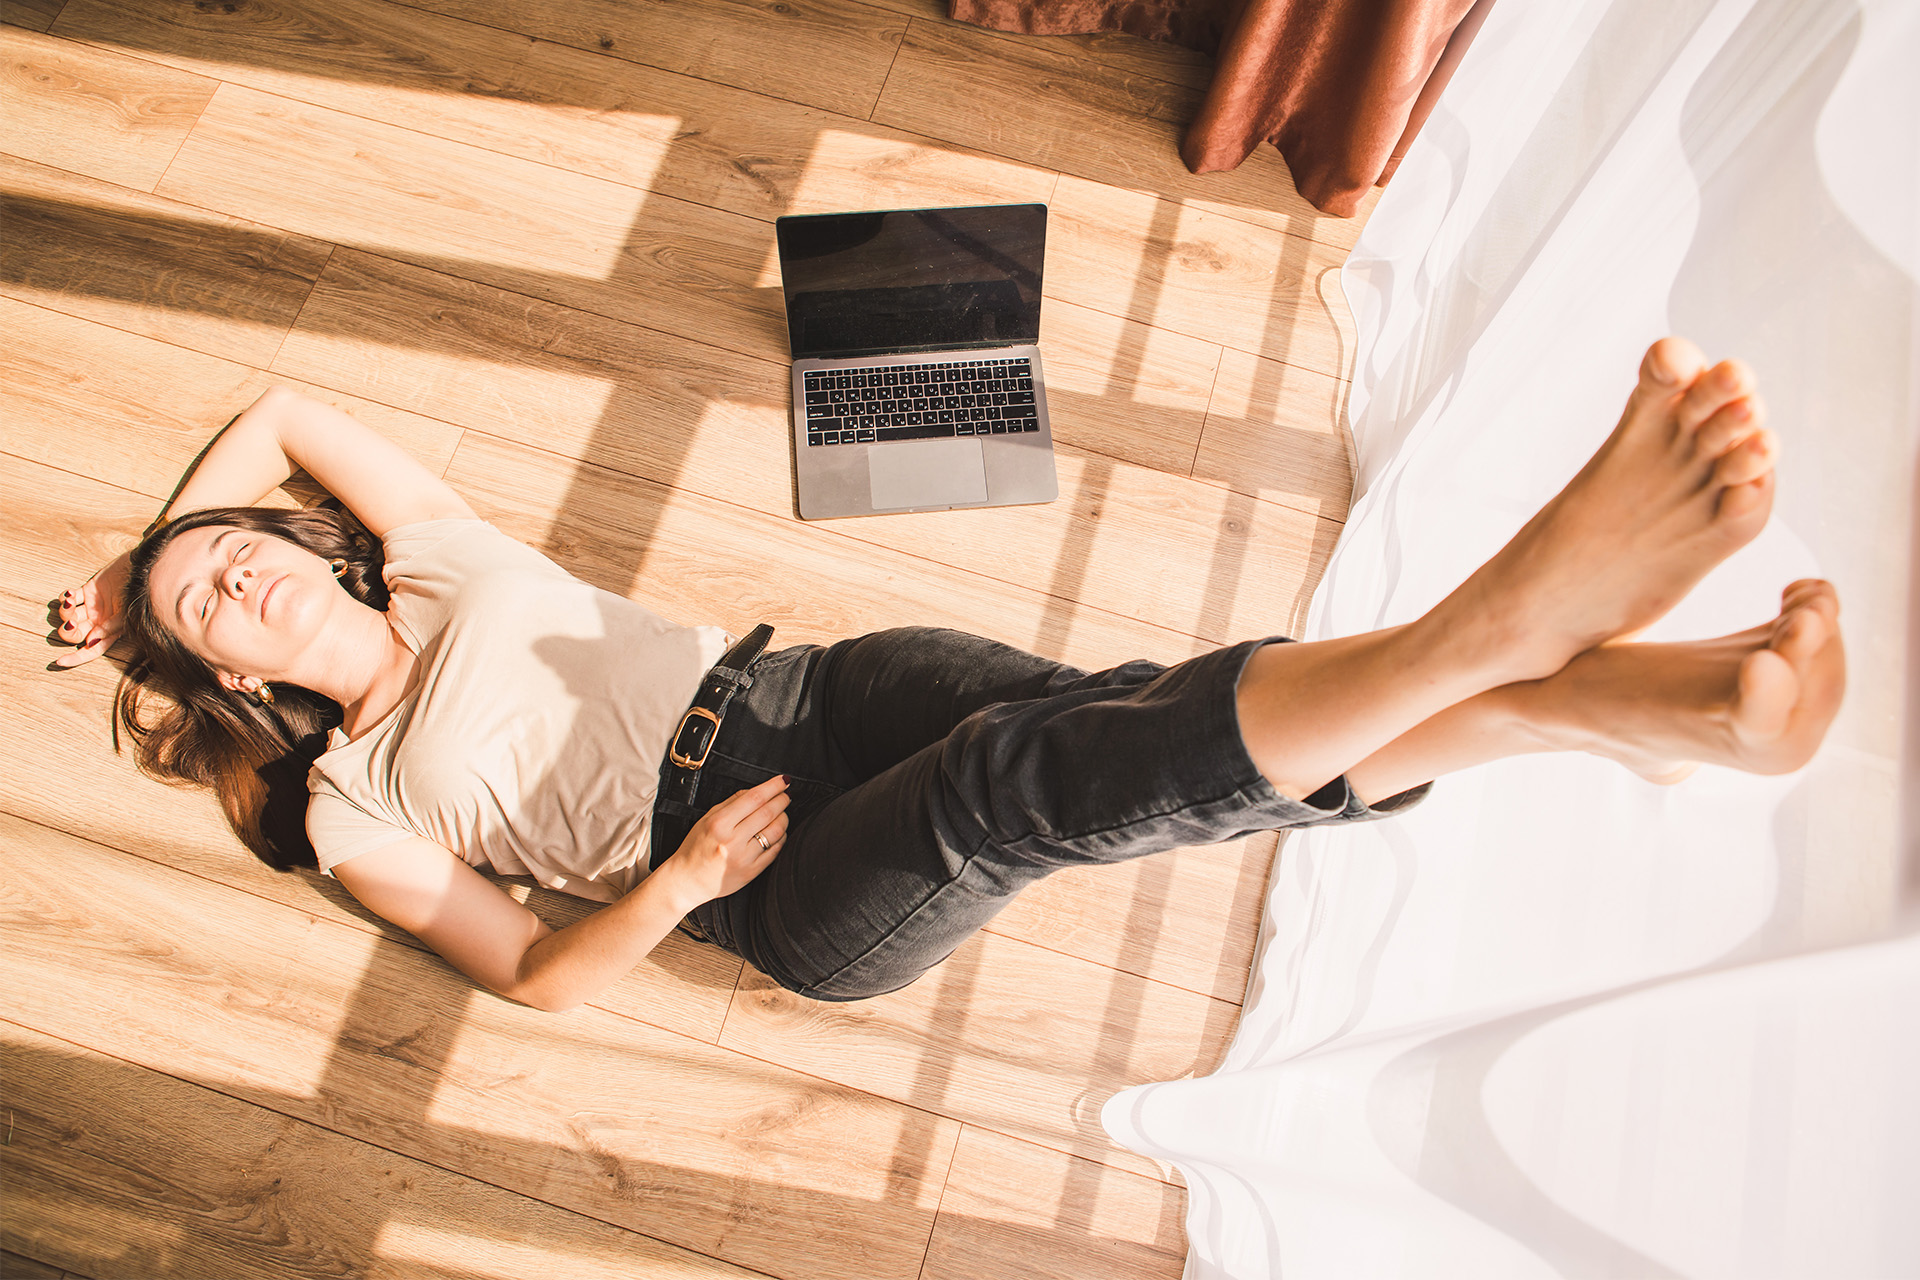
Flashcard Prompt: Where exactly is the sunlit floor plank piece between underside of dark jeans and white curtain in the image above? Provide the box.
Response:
[987,835,1277,1004]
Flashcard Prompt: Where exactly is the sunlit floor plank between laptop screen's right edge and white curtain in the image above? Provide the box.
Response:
[1046,177,1352,378]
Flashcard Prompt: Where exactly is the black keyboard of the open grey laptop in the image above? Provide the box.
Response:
[806,357,1041,445]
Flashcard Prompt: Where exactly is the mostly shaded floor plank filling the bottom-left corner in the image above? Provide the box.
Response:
[0,1023,762,1280]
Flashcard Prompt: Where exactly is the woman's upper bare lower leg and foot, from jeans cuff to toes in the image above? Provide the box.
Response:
[1240,338,1774,796]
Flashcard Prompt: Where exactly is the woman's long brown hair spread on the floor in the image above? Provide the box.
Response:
[113,505,388,871]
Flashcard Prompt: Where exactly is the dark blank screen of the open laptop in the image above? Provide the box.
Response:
[774,205,1046,359]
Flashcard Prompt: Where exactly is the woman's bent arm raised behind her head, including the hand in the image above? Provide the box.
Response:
[54,388,474,666]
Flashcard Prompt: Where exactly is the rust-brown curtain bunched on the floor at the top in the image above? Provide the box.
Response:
[950,0,1492,217]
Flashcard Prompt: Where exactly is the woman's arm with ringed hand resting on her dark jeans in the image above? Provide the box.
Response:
[334,777,787,1011]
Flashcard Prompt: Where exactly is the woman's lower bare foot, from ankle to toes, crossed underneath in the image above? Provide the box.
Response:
[1534,578,1847,783]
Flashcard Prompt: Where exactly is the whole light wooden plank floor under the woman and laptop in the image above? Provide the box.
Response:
[0,0,1357,1280]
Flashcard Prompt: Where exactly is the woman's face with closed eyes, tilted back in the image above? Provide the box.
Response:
[148,524,351,689]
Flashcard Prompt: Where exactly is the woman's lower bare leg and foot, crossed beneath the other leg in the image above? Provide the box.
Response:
[1348,580,1847,800]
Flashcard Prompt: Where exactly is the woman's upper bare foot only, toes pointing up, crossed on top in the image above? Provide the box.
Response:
[1442,338,1778,679]
